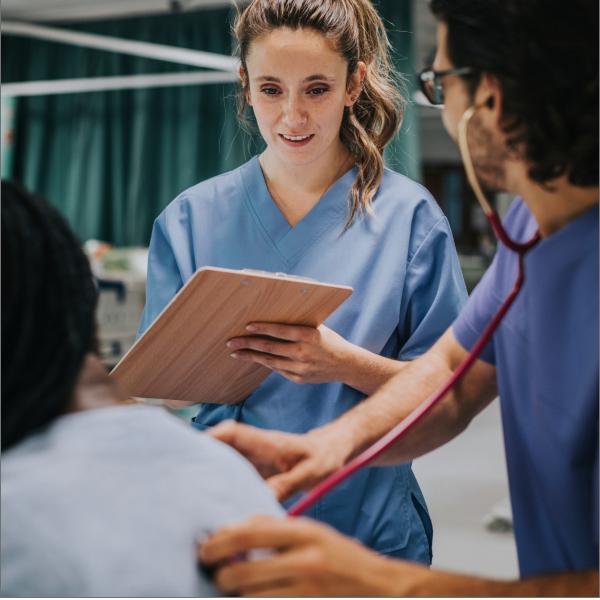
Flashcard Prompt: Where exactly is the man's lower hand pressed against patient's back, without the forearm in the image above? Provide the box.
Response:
[198,517,412,597]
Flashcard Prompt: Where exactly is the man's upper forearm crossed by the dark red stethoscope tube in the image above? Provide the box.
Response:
[314,332,495,464]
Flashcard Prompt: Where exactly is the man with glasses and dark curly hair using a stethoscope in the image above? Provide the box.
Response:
[199,0,598,596]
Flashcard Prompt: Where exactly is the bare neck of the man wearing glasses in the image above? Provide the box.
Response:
[507,163,598,237]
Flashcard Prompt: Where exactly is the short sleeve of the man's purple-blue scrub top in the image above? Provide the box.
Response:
[452,254,500,364]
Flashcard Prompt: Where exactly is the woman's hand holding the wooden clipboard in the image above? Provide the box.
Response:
[227,323,360,383]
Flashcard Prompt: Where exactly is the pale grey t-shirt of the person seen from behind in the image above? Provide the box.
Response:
[0,405,282,597]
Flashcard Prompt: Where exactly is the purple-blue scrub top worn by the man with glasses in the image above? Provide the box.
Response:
[453,200,598,577]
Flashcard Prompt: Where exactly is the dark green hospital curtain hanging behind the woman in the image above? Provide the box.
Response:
[2,0,418,245]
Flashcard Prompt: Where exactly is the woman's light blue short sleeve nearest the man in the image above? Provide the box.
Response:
[398,216,467,360]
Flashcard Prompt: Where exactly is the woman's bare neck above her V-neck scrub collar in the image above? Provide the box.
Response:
[259,140,352,227]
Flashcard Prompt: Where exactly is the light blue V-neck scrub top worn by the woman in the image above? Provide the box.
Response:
[140,158,466,563]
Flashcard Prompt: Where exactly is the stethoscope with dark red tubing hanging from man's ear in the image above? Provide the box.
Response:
[287,100,541,517]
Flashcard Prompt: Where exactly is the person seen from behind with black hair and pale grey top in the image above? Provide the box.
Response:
[0,182,281,597]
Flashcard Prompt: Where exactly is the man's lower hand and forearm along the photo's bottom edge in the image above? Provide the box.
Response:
[198,517,598,597]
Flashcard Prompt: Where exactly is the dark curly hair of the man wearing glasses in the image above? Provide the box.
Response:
[431,0,598,187]
